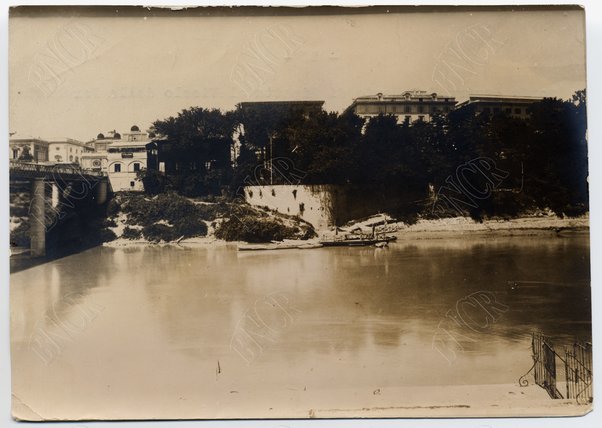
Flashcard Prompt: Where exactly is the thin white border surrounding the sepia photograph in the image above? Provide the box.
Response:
[0,0,602,428]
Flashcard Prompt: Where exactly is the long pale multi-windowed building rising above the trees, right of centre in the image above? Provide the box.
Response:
[346,91,456,123]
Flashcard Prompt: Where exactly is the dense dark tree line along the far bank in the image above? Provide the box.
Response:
[142,90,588,219]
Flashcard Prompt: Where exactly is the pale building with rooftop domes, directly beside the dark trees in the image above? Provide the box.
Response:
[106,125,151,192]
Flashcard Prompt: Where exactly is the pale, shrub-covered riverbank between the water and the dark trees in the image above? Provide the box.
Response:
[104,199,589,247]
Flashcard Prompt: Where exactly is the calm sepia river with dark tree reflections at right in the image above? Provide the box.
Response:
[10,235,591,419]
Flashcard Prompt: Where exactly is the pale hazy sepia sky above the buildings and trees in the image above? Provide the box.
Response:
[9,7,585,141]
